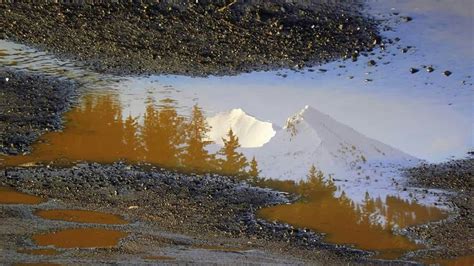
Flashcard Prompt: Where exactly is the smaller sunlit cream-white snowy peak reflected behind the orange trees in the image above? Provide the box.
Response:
[207,108,276,148]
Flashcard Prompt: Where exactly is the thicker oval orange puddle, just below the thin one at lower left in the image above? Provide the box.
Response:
[33,228,127,248]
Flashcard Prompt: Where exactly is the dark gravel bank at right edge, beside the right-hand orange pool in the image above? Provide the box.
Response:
[407,158,474,259]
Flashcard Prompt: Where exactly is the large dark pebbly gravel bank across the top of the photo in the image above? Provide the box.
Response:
[0,0,381,76]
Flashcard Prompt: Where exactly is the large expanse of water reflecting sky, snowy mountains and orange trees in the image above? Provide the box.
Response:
[0,0,474,258]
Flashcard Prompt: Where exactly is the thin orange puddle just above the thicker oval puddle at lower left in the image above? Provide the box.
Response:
[35,210,128,224]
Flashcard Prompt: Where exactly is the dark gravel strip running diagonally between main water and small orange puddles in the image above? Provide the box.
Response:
[0,163,416,263]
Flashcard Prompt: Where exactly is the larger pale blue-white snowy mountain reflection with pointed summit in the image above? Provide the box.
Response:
[244,106,444,203]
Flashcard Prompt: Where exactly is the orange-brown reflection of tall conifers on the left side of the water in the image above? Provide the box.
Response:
[0,94,252,176]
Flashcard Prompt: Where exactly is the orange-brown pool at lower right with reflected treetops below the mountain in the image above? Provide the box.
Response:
[259,167,446,258]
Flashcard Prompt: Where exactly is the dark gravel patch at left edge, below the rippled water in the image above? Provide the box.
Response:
[0,68,77,155]
